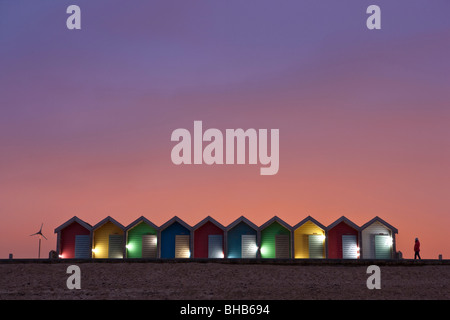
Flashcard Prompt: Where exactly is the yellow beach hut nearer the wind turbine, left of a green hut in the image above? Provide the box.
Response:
[92,216,125,259]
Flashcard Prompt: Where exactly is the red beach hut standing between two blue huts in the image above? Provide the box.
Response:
[192,216,226,258]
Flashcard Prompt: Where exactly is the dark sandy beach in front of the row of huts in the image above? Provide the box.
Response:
[0,262,450,300]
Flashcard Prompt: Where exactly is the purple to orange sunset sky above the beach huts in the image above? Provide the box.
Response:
[0,0,450,259]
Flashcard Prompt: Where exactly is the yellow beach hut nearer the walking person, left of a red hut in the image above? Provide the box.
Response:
[292,216,326,259]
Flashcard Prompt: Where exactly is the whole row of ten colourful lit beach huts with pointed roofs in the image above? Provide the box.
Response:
[55,216,398,259]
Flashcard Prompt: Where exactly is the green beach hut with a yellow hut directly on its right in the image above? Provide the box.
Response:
[259,216,291,259]
